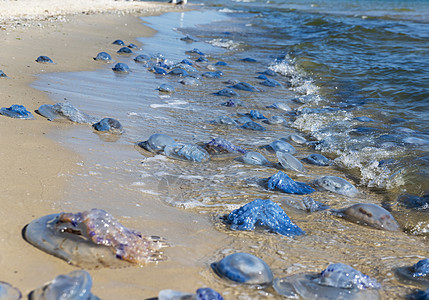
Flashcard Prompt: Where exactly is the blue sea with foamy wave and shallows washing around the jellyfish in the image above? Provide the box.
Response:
[34,0,429,299]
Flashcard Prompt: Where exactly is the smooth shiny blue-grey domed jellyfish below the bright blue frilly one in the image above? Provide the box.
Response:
[211,252,273,285]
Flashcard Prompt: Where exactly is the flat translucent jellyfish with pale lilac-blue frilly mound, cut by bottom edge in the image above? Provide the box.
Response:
[273,263,381,300]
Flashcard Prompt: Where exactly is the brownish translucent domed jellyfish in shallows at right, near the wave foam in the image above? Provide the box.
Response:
[333,203,400,231]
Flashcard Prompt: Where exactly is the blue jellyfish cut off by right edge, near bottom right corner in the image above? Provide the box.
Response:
[395,258,429,288]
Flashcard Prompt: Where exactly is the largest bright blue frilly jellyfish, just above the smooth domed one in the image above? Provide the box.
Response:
[225,199,304,236]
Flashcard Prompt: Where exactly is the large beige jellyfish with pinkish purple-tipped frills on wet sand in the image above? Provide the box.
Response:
[24,209,165,268]
